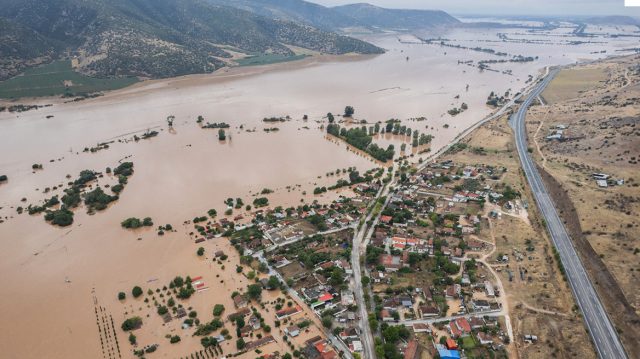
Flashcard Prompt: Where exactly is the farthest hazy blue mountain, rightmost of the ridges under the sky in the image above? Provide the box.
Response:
[331,4,460,30]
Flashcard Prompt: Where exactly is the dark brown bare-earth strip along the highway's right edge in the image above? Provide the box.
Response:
[536,164,640,353]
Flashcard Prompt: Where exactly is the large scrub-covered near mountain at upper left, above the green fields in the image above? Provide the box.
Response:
[0,0,383,79]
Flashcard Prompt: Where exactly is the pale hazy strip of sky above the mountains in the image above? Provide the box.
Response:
[307,0,640,18]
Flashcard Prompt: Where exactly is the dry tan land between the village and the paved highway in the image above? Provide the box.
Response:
[443,116,596,358]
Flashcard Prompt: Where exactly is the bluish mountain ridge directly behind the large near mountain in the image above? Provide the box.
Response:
[205,0,370,32]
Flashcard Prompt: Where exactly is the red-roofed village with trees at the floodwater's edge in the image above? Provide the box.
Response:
[114,161,537,359]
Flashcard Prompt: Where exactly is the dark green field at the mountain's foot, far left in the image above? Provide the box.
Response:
[0,61,139,99]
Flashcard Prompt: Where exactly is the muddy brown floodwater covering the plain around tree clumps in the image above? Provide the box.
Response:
[0,29,638,358]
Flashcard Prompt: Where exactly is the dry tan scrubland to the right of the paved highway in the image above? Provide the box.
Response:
[527,55,640,352]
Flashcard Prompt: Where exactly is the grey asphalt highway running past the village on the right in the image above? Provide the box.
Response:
[509,69,629,359]
